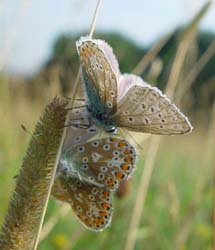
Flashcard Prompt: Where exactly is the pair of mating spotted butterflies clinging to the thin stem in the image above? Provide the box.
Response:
[52,37,192,231]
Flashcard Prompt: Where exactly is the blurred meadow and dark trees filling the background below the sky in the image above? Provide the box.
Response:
[0,1,215,250]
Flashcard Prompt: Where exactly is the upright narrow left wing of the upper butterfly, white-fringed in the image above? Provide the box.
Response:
[76,37,120,114]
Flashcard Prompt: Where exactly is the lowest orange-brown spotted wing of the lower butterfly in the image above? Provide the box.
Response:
[52,176,112,231]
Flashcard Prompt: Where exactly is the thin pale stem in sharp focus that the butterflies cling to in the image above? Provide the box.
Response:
[33,0,102,250]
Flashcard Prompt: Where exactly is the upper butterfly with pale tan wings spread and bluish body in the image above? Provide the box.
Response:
[76,37,192,135]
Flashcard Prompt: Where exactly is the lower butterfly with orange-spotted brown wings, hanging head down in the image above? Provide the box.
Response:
[52,105,136,231]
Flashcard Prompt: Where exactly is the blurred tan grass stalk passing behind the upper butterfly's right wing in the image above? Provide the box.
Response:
[125,2,210,250]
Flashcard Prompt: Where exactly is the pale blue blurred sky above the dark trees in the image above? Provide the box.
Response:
[0,0,215,74]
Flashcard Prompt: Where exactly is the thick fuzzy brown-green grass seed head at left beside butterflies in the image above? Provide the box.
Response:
[0,98,68,250]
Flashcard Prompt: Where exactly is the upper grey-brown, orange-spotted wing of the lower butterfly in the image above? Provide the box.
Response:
[61,138,136,190]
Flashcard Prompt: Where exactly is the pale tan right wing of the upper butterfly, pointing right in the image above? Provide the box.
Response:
[114,75,192,135]
